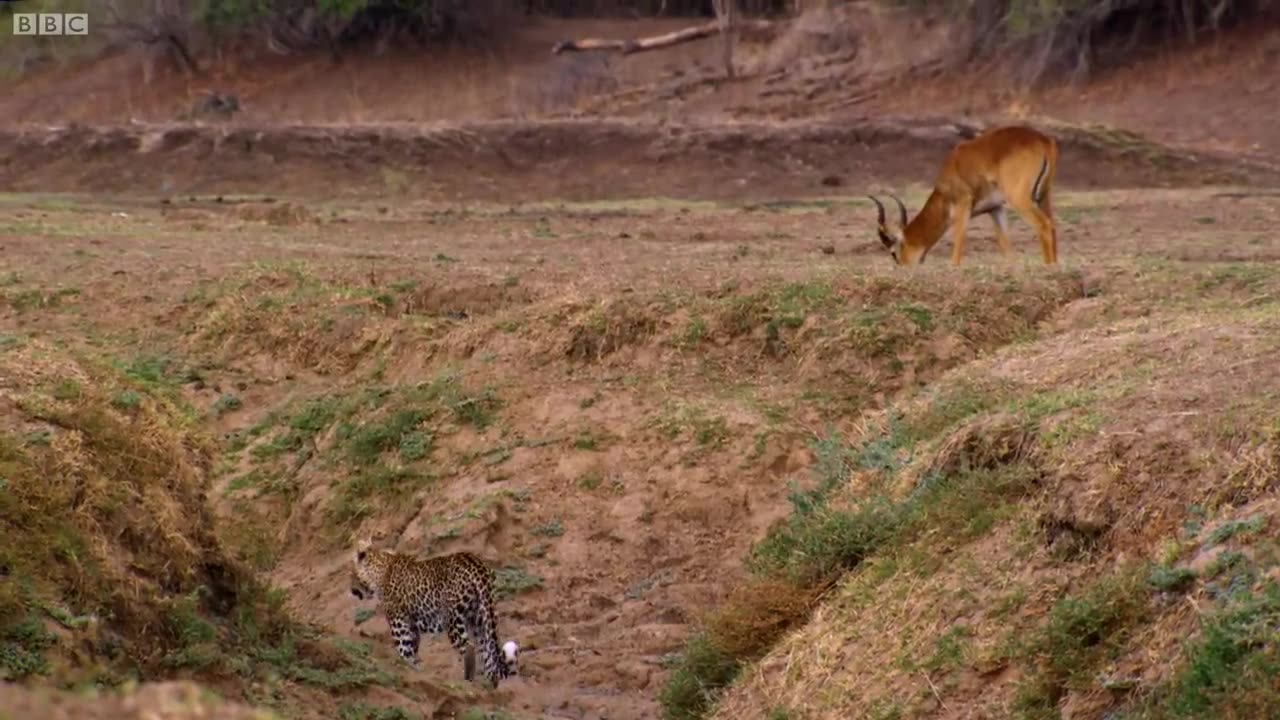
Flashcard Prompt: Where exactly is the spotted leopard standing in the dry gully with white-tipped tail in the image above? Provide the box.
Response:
[351,541,520,688]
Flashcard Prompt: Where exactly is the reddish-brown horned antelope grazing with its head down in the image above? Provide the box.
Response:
[868,126,1057,265]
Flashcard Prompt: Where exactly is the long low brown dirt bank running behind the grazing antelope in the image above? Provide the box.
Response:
[0,120,1280,202]
